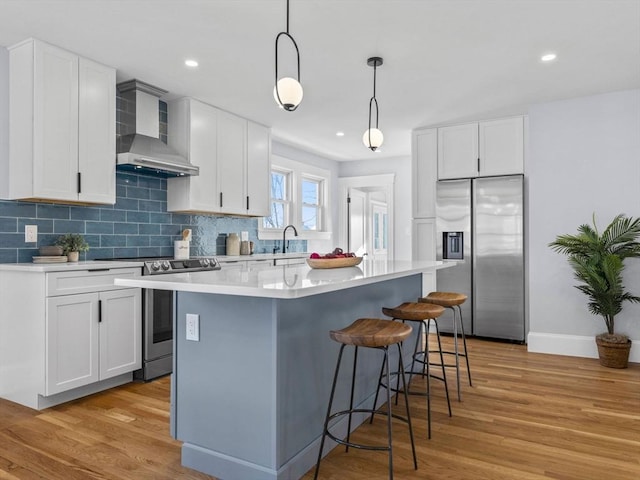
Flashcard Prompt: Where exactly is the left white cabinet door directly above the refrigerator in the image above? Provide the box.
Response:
[438,123,478,180]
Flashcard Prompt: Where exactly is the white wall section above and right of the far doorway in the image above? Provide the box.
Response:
[338,157,411,260]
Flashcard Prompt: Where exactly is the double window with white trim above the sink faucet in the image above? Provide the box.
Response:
[258,155,331,240]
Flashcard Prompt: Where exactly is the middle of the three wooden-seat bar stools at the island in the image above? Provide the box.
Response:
[374,302,451,438]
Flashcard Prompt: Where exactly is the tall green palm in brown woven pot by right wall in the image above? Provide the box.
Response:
[549,214,640,368]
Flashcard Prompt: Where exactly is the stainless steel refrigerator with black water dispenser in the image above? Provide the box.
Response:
[436,175,525,342]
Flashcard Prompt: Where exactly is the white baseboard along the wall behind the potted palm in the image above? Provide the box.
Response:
[527,332,640,363]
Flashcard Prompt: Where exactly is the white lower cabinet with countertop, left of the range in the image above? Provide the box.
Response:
[0,268,142,409]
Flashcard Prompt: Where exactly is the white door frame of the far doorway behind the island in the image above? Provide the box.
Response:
[338,173,396,260]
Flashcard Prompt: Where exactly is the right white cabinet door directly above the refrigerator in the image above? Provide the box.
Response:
[479,117,524,176]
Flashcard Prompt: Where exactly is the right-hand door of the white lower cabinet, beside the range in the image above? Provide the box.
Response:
[99,288,142,380]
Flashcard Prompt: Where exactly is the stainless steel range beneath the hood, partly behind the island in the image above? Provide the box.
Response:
[102,257,220,381]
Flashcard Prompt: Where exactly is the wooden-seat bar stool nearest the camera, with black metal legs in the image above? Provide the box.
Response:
[313,318,418,479]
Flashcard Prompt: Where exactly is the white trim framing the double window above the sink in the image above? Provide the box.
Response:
[258,155,332,240]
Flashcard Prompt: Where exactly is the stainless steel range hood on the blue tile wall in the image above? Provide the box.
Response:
[116,80,200,177]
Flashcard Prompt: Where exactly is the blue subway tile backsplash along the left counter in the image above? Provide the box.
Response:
[0,172,307,263]
